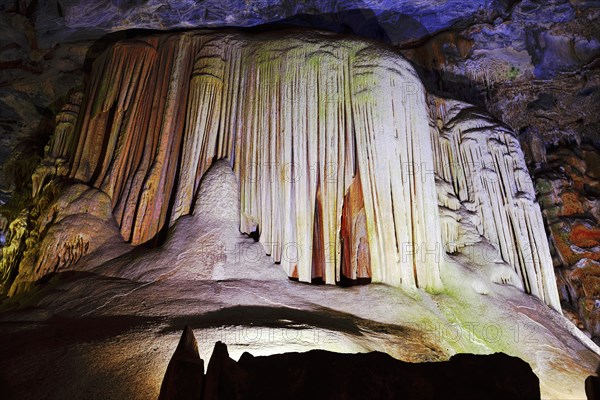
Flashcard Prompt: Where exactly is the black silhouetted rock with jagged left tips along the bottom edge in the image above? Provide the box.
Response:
[161,328,540,400]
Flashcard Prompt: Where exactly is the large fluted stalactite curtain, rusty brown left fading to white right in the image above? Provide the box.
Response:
[64,32,442,290]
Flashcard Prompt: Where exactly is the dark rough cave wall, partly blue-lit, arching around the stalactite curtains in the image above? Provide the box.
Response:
[0,0,600,328]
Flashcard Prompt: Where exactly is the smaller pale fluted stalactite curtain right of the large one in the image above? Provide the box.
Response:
[430,96,560,310]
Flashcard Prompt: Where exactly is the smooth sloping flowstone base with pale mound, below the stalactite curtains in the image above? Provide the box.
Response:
[0,182,600,399]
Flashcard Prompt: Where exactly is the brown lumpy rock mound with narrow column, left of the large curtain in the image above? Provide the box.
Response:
[0,93,123,295]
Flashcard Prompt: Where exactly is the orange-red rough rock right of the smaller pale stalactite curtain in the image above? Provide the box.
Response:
[533,144,600,337]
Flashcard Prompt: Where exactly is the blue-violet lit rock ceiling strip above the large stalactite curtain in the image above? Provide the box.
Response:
[30,0,512,44]
